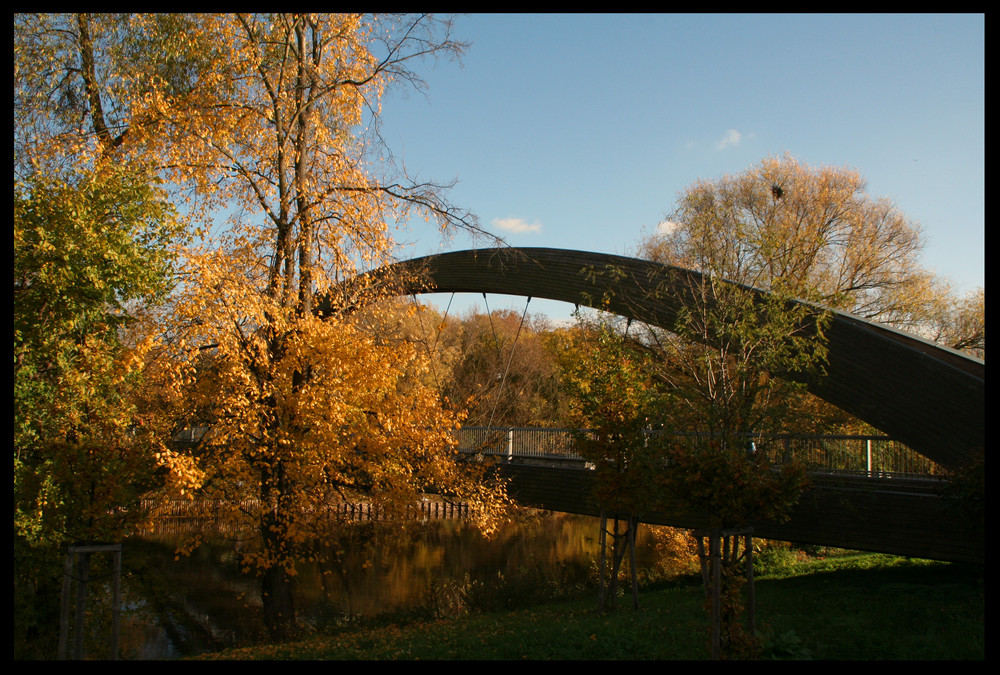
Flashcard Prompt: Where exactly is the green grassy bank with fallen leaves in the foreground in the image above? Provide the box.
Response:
[195,554,985,660]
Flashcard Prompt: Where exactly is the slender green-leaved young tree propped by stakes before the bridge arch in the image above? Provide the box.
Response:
[584,269,827,657]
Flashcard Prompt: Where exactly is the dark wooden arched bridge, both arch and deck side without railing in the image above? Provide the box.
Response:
[330,248,986,562]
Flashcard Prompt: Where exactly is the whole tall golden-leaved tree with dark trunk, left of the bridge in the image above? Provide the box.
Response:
[15,14,503,637]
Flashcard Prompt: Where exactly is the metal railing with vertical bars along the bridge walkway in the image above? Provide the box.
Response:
[457,427,946,477]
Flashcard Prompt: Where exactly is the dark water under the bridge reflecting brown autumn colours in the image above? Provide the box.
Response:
[121,513,655,659]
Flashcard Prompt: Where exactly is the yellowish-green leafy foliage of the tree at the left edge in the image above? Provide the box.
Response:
[14,167,177,541]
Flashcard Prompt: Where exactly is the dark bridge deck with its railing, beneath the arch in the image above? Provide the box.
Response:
[460,428,985,564]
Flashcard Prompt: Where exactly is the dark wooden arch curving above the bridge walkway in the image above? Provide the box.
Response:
[330,248,986,468]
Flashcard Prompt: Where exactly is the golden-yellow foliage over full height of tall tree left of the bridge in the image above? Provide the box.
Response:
[24,14,516,588]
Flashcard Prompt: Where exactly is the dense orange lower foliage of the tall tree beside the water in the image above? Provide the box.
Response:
[161,277,505,564]
